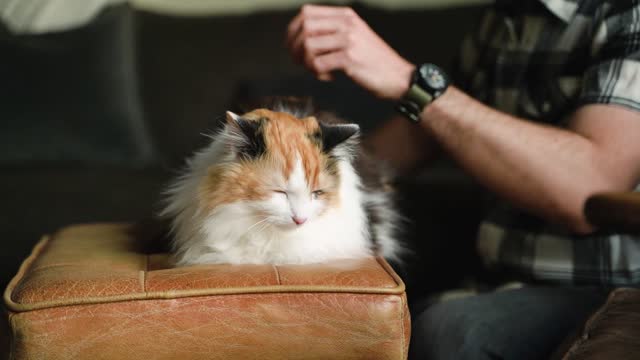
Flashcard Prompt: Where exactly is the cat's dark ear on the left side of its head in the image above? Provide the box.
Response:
[226,111,266,159]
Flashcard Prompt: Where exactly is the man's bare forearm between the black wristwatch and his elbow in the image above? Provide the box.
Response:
[420,87,616,232]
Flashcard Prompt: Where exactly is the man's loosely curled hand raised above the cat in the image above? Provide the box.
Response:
[287,5,415,100]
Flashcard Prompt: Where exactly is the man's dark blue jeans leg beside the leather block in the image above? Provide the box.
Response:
[409,287,608,360]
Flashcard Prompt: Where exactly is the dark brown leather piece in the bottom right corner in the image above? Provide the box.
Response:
[562,288,640,360]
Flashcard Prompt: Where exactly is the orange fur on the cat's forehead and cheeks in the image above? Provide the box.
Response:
[200,109,339,210]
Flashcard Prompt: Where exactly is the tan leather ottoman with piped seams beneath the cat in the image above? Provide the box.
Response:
[4,224,410,360]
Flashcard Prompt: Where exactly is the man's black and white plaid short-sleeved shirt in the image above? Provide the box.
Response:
[460,0,640,286]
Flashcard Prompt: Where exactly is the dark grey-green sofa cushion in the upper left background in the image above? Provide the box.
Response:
[0,5,153,165]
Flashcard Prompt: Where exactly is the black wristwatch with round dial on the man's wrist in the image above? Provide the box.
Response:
[396,63,449,122]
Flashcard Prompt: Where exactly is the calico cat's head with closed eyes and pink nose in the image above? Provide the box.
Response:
[201,109,358,229]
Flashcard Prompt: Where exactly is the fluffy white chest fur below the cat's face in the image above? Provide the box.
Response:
[177,163,372,264]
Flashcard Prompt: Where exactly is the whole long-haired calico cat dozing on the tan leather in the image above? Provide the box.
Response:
[161,101,401,265]
